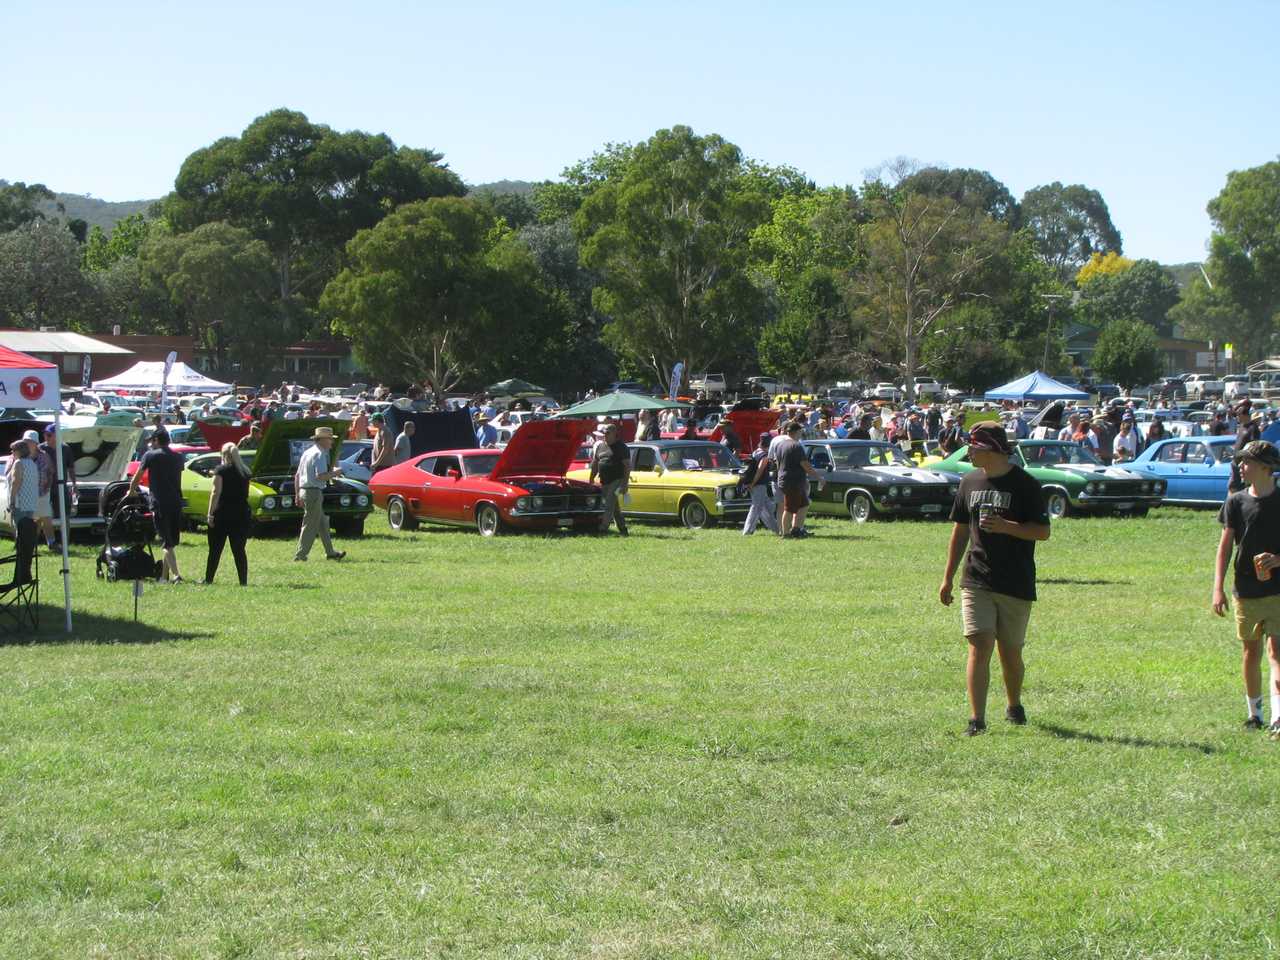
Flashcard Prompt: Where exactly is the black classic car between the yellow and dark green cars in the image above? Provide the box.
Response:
[801,440,960,524]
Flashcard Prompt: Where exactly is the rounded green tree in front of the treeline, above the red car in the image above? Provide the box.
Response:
[320,197,532,390]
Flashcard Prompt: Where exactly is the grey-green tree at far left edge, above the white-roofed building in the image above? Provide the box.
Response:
[0,219,97,329]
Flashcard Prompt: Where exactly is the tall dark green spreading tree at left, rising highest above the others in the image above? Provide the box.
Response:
[164,110,466,303]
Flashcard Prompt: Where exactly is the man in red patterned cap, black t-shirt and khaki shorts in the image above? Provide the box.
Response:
[938,420,1050,736]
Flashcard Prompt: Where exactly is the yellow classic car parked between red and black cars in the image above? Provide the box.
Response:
[567,440,751,530]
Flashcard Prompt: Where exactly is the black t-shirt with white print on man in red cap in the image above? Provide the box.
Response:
[951,466,1048,600]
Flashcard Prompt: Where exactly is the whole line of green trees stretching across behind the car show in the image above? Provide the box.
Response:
[0,110,1280,399]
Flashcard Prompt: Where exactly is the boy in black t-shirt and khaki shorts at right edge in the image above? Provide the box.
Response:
[1212,440,1280,740]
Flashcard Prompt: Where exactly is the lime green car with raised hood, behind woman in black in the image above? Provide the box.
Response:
[105,419,374,536]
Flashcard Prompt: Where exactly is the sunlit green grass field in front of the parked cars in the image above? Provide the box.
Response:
[0,509,1280,959]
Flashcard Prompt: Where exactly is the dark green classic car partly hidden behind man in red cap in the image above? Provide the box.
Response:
[934,440,1166,518]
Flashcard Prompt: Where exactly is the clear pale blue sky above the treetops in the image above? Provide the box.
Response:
[0,0,1280,262]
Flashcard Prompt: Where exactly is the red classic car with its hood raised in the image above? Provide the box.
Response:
[369,420,604,536]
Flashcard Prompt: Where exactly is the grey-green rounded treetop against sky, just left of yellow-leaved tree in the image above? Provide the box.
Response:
[1021,182,1123,282]
